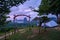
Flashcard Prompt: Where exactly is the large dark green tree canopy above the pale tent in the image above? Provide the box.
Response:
[39,0,60,15]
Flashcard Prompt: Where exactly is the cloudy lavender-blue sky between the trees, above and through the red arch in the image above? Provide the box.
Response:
[7,0,41,20]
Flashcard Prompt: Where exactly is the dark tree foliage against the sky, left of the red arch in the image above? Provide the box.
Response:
[0,0,26,26]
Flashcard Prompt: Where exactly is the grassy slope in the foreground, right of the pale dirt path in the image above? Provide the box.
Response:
[7,28,60,40]
